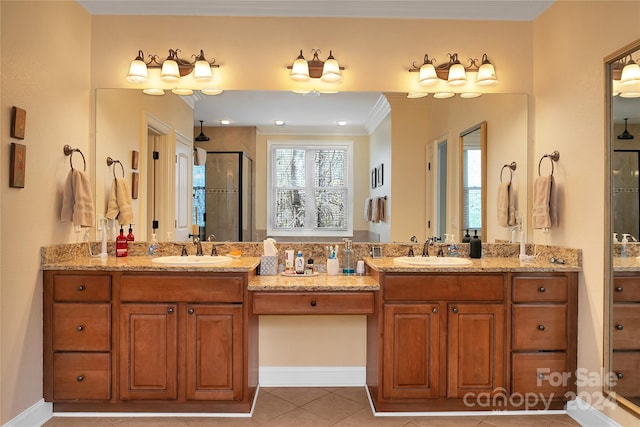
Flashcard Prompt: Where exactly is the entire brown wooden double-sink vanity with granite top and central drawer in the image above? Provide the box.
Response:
[43,247,580,413]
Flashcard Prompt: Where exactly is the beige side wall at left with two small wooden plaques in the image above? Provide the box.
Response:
[0,1,91,424]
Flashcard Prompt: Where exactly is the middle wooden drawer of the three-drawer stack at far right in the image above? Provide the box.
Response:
[513,304,567,350]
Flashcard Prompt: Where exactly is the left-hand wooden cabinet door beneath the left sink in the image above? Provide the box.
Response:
[119,303,178,400]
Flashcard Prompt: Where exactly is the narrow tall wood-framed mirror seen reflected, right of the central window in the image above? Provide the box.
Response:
[459,122,487,242]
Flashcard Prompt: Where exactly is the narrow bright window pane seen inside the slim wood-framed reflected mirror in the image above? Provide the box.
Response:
[462,144,482,234]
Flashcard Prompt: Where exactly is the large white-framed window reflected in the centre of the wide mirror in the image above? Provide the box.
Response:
[267,142,352,236]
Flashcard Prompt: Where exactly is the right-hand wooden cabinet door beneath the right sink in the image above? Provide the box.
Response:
[447,303,505,398]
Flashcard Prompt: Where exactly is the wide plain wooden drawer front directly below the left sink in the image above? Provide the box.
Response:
[120,274,244,302]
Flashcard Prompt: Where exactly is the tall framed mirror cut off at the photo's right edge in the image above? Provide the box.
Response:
[605,40,640,416]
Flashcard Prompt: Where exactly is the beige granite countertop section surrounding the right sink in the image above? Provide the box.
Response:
[364,256,580,273]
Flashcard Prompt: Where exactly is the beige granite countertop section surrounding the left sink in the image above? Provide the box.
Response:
[42,256,260,273]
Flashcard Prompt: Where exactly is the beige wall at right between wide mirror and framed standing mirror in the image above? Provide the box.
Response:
[529,1,640,426]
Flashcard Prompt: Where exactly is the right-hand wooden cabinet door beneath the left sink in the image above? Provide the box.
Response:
[185,304,243,400]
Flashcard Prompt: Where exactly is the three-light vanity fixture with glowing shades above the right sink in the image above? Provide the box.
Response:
[408,53,498,99]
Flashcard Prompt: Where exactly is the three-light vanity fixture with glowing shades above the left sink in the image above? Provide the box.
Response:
[127,49,222,96]
